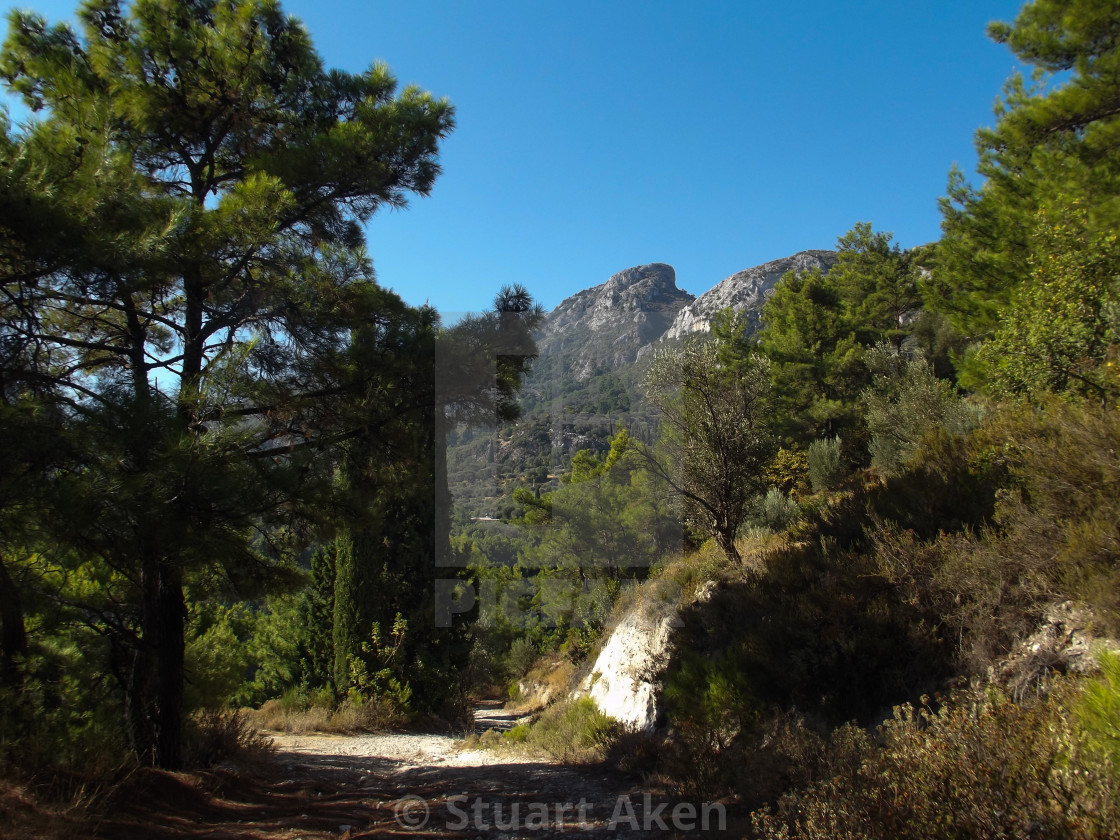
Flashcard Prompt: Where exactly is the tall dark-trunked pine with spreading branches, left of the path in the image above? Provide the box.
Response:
[0,0,451,768]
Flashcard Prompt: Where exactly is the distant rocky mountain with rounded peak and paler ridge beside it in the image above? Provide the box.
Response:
[448,251,836,520]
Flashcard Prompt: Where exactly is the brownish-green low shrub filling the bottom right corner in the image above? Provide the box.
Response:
[753,681,1120,840]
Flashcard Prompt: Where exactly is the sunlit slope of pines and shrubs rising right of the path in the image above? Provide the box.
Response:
[439,2,1120,838]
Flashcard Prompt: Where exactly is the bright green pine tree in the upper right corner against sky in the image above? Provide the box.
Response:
[930,0,1120,344]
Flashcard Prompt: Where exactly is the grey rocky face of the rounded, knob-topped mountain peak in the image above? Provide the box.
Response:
[536,262,693,379]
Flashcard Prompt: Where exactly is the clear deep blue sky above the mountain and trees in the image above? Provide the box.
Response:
[6,0,1021,317]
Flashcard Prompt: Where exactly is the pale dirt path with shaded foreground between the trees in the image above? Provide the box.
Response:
[96,708,719,840]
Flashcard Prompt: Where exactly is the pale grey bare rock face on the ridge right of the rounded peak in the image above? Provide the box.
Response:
[664,251,837,338]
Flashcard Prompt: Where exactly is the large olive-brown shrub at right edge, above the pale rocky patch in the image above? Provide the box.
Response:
[869,399,1120,673]
